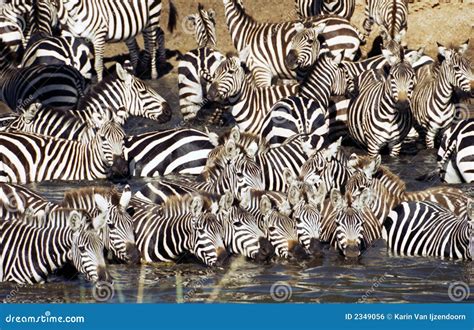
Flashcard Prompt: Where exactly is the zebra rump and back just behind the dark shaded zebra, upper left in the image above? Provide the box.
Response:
[21,31,94,81]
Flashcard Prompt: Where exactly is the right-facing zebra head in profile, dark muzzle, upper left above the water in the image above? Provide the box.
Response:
[116,63,172,124]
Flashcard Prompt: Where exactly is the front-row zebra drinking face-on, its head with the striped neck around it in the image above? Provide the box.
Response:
[321,189,382,259]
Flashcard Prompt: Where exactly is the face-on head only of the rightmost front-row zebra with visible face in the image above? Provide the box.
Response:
[330,189,372,258]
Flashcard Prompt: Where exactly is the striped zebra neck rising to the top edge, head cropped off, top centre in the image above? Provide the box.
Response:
[225,0,258,51]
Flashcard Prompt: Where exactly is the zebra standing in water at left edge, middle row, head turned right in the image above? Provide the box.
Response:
[0,117,128,183]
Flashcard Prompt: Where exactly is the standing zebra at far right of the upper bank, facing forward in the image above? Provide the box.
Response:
[411,40,474,148]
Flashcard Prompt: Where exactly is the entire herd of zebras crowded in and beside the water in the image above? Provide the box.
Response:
[0,0,474,290]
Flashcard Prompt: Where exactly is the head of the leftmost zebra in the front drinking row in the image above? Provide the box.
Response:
[68,212,112,282]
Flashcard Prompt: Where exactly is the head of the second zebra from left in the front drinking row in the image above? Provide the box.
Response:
[94,185,140,264]
